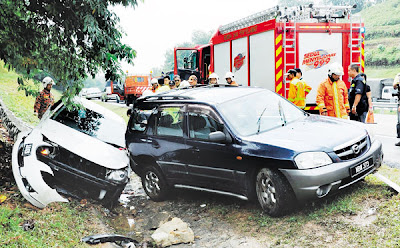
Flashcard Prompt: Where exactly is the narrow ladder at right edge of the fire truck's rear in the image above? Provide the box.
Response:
[348,13,363,68]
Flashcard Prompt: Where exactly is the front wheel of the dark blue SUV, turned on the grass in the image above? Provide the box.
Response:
[255,168,295,217]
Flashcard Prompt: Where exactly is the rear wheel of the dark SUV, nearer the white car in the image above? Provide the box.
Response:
[142,166,169,201]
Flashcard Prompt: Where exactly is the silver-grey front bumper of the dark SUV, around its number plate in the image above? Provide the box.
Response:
[280,140,383,201]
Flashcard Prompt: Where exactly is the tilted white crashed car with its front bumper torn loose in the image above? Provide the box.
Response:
[12,98,130,208]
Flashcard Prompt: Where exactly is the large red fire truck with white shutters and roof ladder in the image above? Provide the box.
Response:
[174,5,365,111]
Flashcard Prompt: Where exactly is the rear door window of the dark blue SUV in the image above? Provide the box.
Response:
[156,107,184,137]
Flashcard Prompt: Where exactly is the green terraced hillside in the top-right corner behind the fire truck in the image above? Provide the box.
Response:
[361,0,400,77]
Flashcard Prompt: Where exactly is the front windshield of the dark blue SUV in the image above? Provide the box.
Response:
[218,90,304,136]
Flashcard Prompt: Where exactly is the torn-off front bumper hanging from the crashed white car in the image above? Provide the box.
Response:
[12,133,128,208]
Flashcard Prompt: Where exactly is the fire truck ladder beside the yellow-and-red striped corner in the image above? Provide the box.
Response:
[282,22,297,97]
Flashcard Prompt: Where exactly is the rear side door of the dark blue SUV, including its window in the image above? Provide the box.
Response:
[142,105,191,183]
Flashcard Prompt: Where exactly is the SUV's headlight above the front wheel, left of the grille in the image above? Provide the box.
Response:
[294,152,332,169]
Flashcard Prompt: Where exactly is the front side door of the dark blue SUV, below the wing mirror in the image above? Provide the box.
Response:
[186,105,246,193]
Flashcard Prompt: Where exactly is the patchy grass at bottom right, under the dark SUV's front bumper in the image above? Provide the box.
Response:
[203,166,400,247]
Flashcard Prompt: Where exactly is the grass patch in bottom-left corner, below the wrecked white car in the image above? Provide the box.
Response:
[0,195,100,248]
